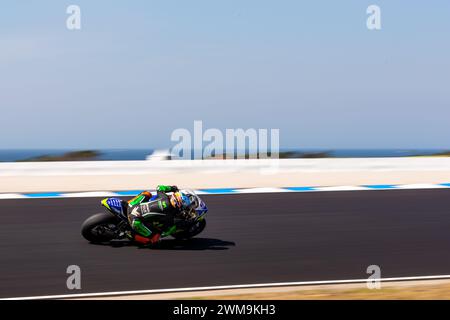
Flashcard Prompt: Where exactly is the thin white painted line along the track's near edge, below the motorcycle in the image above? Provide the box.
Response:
[5,275,450,300]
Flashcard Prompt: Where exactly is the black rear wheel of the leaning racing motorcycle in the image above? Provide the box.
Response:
[81,212,117,243]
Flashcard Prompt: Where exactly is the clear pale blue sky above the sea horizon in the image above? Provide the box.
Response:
[0,0,450,149]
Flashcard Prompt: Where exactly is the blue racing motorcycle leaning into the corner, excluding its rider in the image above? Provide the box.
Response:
[81,190,208,243]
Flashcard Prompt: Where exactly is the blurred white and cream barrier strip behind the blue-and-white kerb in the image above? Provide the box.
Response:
[0,157,450,193]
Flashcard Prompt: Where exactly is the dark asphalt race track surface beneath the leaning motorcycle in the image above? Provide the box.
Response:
[0,189,450,298]
